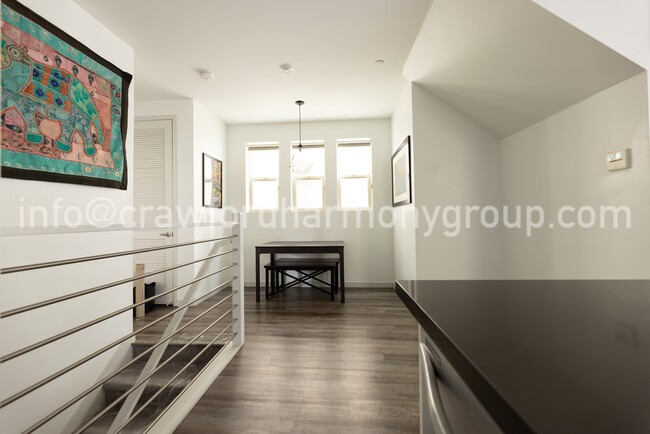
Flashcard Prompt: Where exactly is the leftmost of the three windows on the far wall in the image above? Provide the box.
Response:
[247,143,280,210]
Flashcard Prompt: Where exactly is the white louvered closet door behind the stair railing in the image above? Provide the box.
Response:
[133,119,176,304]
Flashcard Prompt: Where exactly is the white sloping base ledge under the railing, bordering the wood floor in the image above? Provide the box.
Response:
[147,342,241,434]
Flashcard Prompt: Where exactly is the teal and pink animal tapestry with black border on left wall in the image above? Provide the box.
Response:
[0,0,132,190]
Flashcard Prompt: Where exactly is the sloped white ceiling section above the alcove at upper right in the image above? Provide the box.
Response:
[404,0,643,138]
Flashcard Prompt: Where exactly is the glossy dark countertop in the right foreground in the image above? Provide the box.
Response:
[395,280,650,434]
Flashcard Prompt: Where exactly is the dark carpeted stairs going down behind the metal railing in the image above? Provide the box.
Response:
[83,342,222,434]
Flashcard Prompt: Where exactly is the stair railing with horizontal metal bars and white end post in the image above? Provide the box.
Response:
[0,222,244,434]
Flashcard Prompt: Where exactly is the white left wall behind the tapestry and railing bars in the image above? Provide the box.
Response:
[0,0,134,432]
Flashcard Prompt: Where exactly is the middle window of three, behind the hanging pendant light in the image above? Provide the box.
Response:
[291,142,325,210]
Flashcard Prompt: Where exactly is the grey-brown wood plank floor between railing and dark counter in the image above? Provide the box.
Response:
[176,288,419,434]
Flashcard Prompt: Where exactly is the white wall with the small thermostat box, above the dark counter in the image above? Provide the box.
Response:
[502,73,650,279]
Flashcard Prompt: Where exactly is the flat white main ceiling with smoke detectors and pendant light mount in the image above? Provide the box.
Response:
[74,0,431,124]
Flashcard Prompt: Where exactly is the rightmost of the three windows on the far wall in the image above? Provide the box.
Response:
[337,139,372,209]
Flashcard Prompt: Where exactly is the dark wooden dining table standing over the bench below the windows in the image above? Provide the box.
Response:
[255,241,345,303]
